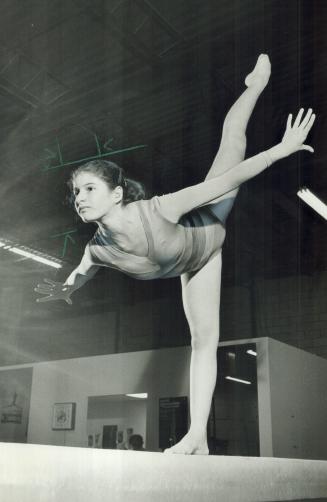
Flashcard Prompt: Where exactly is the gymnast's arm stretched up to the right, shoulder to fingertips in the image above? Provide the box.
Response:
[160,109,315,222]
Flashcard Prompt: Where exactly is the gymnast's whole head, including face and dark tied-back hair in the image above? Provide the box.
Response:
[68,160,145,222]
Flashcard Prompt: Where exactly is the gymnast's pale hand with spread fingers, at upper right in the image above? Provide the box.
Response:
[280,108,316,157]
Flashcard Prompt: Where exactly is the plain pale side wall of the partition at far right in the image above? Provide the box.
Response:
[268,339,327,460]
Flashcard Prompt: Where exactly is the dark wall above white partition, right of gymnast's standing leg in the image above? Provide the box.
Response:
[221,272,327,357]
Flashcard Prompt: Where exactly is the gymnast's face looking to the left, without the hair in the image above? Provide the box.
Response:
[73,172,121,223]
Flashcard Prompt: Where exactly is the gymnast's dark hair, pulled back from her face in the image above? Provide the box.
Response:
[68,160,145,204]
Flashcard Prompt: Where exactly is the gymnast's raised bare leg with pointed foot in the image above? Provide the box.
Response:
[206,54,271,202]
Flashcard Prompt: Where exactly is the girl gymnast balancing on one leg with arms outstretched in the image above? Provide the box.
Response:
[35,55,315,454]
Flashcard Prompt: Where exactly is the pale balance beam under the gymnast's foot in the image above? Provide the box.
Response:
[0,443,327,502]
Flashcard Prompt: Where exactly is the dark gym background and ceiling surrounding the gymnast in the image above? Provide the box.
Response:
[0,0,327,365]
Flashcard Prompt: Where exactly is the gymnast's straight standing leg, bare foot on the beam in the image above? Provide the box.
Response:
[165,252,221,455]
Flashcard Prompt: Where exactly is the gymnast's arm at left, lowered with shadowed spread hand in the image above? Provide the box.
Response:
[34,245,99,305]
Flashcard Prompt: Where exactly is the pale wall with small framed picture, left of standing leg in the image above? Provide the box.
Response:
[3,347,189,450]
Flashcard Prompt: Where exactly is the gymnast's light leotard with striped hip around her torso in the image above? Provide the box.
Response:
[87,195,233,280]
